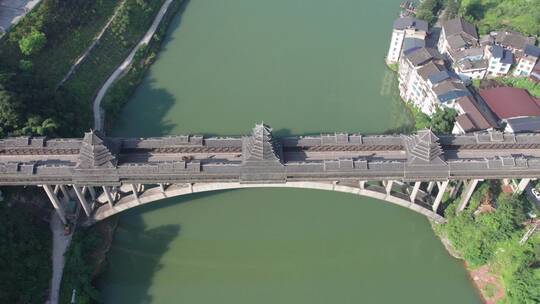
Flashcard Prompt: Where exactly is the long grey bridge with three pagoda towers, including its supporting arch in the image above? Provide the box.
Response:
[0,124,540,222]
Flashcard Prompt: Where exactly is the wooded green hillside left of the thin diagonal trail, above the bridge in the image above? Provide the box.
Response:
[0,0,122,137]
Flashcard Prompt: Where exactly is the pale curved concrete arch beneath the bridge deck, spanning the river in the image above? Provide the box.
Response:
[86,182,446,225]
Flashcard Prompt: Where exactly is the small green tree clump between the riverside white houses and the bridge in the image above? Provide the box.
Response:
[406,103,457,134]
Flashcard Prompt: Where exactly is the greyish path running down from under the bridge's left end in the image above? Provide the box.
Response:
[47,211,73,304]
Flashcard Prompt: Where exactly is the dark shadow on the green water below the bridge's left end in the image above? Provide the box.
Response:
[97,190,233,304]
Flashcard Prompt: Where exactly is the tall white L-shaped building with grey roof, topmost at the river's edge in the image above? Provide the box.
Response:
[386,17,428,64]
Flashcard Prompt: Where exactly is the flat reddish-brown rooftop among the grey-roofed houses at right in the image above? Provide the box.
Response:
[480,87,540,120]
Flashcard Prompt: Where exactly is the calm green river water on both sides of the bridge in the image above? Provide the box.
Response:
[100,0,480,304]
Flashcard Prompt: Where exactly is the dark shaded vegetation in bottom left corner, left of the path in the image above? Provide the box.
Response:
[0,189,51,304]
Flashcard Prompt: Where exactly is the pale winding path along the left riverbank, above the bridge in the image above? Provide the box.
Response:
[93,0,174,131]
